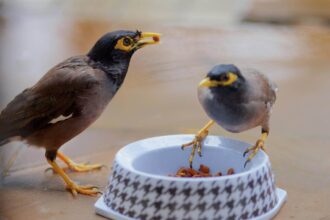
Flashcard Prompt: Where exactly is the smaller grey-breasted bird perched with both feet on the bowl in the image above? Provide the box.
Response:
[181,64,278,167]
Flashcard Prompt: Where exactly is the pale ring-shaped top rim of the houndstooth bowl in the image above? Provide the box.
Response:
[114,134,270,182]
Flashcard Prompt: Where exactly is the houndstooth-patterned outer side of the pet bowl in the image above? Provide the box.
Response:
[104,163,278,220]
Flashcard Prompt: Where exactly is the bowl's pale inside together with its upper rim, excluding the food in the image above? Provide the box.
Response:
[116,135,267,177]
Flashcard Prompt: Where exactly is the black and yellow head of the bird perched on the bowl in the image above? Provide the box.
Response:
[199,64,244,89]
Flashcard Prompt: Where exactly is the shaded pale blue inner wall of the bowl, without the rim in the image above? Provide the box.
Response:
[133,146,245,176]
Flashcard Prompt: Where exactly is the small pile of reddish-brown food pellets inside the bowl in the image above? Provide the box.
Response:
[169,164,235,178]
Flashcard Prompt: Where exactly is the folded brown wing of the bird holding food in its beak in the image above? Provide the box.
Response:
[0,56,99,142]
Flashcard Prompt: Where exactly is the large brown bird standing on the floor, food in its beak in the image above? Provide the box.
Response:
[0,30,160,195]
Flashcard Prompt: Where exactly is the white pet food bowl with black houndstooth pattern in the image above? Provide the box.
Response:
[95,135,286,220]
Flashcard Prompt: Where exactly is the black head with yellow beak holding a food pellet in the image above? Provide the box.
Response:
[88,31,160,64]
